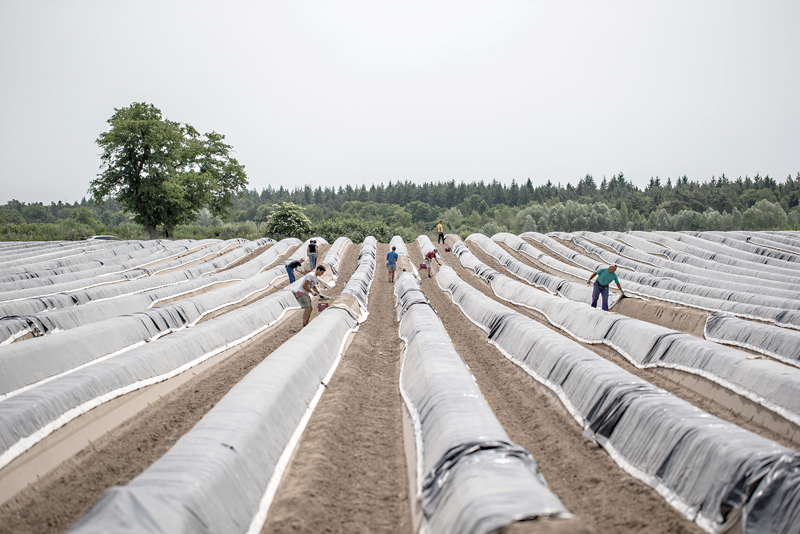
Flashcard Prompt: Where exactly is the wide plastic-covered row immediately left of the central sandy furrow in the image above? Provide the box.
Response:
[62,240,375,534]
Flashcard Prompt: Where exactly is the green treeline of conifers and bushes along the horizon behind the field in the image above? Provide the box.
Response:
[0,173,800,240]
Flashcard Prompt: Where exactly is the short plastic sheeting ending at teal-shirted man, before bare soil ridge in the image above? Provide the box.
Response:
[467,234,620,307]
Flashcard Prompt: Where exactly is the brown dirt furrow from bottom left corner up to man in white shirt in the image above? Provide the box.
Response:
[0,245,358,534]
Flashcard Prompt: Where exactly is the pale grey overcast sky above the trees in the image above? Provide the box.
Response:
[0,0,800,203]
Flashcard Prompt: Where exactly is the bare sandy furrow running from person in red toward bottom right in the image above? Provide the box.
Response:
[408,244,702,534]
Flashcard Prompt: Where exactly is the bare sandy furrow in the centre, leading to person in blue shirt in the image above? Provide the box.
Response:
[262,244,411,533]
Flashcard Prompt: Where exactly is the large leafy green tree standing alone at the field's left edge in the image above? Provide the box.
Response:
[89,102,247,239]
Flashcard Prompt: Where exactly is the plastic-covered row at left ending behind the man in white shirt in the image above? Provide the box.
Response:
[0,236,352,474]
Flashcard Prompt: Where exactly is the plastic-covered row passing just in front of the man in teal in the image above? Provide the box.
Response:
[455,242,800,425]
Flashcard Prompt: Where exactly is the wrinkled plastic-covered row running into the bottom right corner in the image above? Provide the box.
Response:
[437,267,800,534]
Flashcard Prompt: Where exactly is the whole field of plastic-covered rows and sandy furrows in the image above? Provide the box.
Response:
[0,231,800,533]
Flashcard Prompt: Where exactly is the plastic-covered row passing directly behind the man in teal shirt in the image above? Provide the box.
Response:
[522,232,800,329]
